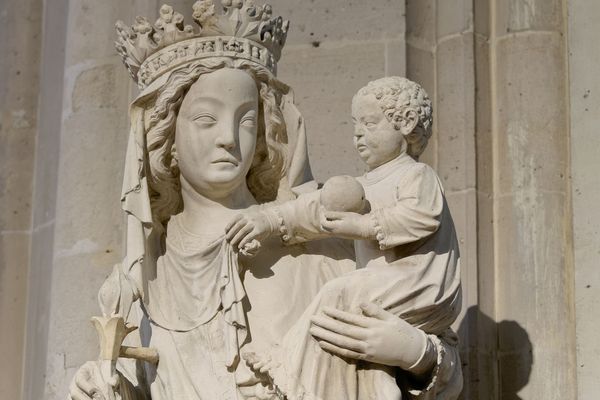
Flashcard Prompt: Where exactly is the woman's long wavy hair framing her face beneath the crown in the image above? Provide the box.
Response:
[145,58,288,230]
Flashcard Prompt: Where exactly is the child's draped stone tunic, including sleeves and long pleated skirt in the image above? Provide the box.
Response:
[264,155,461,400]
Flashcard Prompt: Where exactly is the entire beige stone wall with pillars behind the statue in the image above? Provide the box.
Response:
[0,0,600,400]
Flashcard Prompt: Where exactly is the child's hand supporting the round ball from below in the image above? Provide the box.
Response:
[321,211,377,240]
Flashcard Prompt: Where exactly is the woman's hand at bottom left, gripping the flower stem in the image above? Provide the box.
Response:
[67,361,121,400]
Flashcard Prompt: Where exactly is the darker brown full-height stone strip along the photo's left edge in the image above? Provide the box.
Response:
[0,0,42,399]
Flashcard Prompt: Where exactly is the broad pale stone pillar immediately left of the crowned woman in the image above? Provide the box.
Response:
[36,0,148,400]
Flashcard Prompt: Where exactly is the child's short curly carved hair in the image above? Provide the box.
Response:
[353,76,433,158]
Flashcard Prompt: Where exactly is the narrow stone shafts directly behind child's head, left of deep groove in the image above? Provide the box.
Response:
[406,0,487,399]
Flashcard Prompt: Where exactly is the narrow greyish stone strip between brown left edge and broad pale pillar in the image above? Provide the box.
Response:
[21,0,68,400]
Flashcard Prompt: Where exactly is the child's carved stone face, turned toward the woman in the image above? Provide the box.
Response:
[352,94,405,169]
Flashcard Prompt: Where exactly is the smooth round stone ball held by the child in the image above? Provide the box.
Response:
[321,175,365,213]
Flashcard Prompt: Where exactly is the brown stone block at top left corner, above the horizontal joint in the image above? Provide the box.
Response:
[0,1,41,231]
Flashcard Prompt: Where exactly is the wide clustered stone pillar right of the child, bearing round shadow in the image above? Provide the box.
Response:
[407,0,576,400]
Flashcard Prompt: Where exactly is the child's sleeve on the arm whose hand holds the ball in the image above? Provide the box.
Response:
[371,163,444,250]
